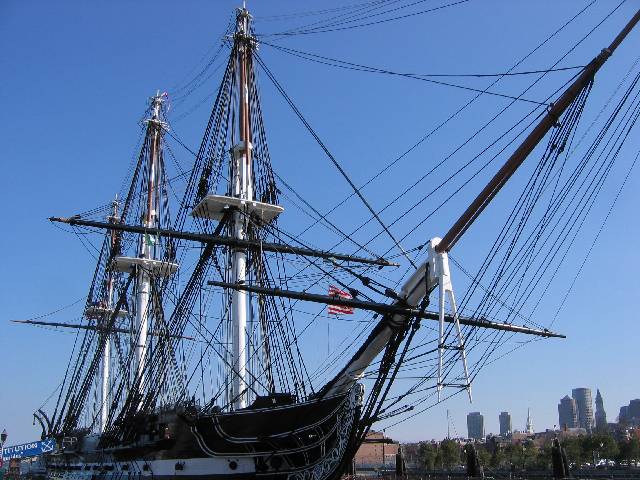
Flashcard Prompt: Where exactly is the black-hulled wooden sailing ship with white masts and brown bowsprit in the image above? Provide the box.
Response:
[17,4,640,480]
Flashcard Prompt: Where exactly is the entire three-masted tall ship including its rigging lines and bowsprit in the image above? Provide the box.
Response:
[13,3,640,480]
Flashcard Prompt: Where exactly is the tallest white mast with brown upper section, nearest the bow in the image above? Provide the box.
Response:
[231,8,253,409]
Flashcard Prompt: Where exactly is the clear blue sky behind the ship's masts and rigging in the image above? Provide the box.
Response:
[0,0,640,443]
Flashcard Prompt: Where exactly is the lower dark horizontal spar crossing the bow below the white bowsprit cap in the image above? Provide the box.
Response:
[207,281,566,338]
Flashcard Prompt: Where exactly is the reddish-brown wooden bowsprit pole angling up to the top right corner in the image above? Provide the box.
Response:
[436,10,640,253]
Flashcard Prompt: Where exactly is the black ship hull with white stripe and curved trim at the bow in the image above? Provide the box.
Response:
[47,386,361,480]
